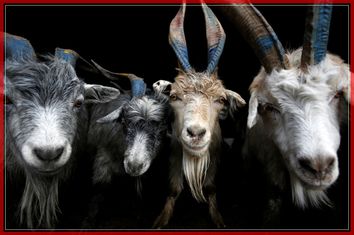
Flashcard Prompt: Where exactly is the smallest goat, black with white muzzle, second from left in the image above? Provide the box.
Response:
[83,64,169,227]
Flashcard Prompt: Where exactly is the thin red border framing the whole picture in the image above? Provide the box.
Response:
[0,0,354,235]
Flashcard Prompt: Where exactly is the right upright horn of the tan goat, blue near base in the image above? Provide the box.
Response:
[202,3,226,73]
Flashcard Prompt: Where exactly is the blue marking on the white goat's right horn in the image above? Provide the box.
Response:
[312,5,332,64]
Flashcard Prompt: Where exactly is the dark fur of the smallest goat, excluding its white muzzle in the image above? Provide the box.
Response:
[82,90,168,228]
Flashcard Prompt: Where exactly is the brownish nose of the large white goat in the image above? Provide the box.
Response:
[299,157,335,177]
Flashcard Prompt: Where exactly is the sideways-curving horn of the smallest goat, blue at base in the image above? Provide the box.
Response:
[91,60,146,97]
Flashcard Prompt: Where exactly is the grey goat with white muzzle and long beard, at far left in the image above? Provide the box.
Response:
[5,34,120,228]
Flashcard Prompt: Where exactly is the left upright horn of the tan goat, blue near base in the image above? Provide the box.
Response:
[168,4,192,72]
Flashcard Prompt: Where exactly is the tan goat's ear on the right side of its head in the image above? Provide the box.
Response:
[219,90,246,120]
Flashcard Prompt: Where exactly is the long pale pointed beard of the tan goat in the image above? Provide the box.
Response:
[182,151,210,202]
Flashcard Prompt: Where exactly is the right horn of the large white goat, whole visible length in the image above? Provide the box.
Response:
[301,5,332,70]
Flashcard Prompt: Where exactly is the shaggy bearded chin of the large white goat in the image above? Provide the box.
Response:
[290,175,332,209]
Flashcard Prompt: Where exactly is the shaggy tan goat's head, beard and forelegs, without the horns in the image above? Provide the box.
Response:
[153,71,245,228]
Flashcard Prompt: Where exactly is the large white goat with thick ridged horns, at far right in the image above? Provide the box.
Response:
[222,5,350,220]
